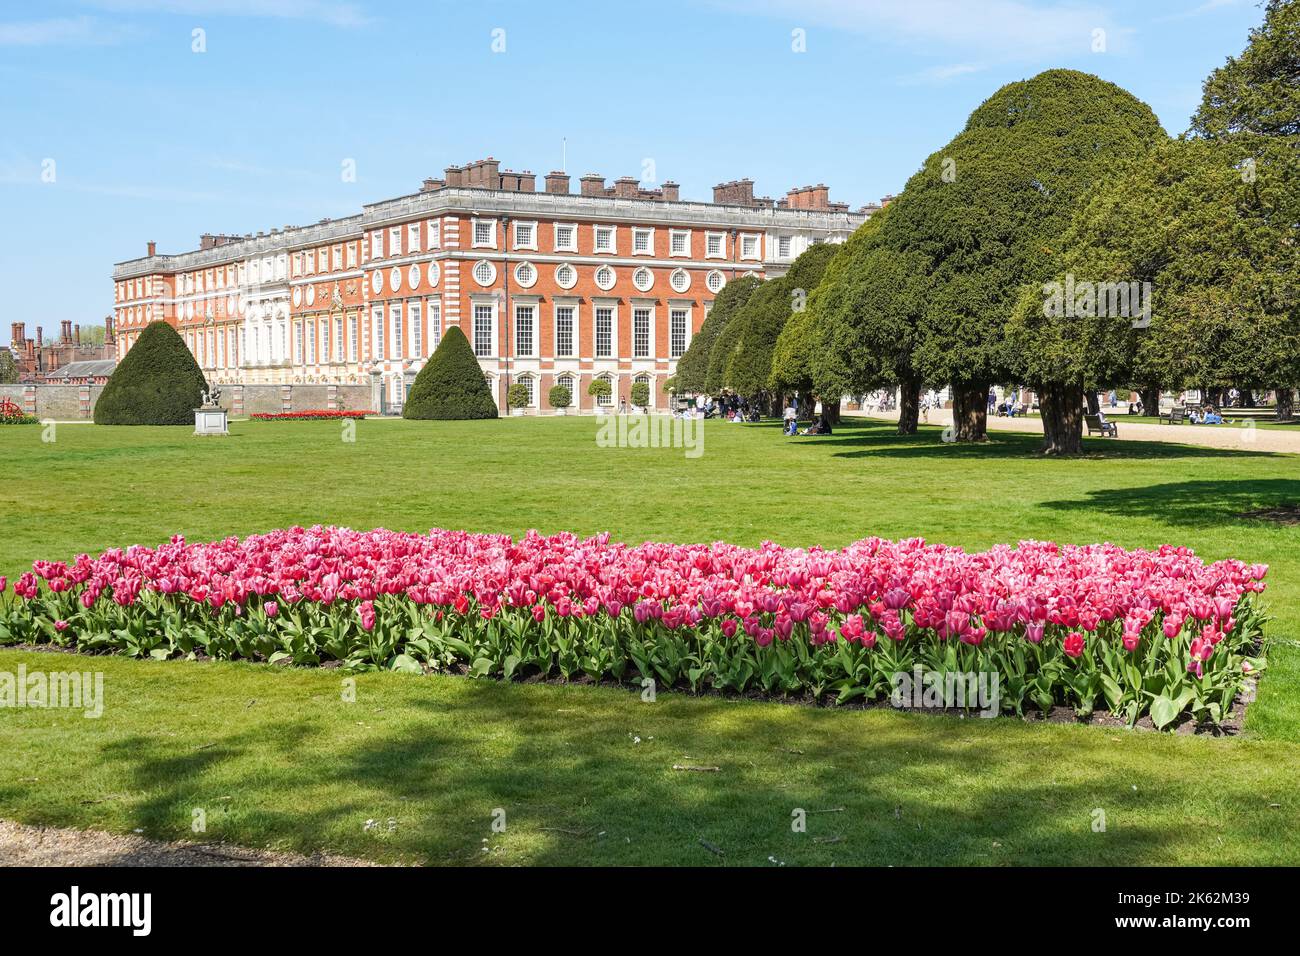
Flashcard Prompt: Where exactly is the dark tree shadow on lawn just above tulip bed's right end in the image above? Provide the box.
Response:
[1040,479,1300,528]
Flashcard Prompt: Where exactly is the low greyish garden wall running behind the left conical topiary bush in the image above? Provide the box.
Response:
[0,384,377,421]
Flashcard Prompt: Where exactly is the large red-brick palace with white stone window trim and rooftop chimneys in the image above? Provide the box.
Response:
[113,159,879,411]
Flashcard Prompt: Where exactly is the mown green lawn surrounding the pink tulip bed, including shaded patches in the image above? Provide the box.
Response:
[0,418,1300,865]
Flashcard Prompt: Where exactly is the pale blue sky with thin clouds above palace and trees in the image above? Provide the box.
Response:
[0,0,1262,342]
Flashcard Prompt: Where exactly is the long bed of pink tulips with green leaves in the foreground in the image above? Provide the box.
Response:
[0,527,1268,727]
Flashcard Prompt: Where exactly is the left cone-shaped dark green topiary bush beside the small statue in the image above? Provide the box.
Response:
[95,321,208,425]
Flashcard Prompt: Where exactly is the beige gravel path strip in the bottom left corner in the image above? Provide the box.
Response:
[0,819,374,866]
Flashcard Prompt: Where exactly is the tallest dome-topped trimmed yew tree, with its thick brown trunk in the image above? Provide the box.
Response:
[883,70,1165,441]
